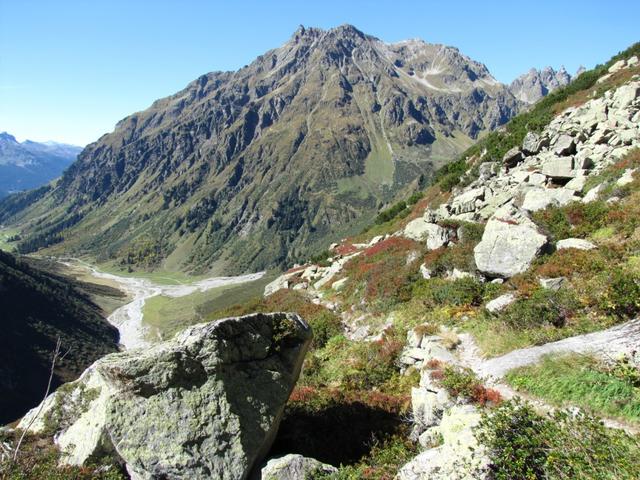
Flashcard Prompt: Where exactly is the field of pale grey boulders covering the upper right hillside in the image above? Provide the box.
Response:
[434,80,640,228]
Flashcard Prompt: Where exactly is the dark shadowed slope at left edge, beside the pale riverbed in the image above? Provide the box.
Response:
[0,251,118,423]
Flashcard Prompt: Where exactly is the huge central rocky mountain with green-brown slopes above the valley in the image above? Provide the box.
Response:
[0,25,521,272]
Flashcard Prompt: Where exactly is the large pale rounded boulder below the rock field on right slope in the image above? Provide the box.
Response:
[473,205,548,278]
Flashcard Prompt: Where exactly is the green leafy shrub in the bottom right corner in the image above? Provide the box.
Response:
[476,400,640,480]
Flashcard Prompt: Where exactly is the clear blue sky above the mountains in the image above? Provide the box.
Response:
[0,0,640,145]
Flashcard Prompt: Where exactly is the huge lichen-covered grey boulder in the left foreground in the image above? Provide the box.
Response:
[19,313,311,480]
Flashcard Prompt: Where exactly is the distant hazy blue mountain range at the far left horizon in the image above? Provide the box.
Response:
[0,132,82,197]
